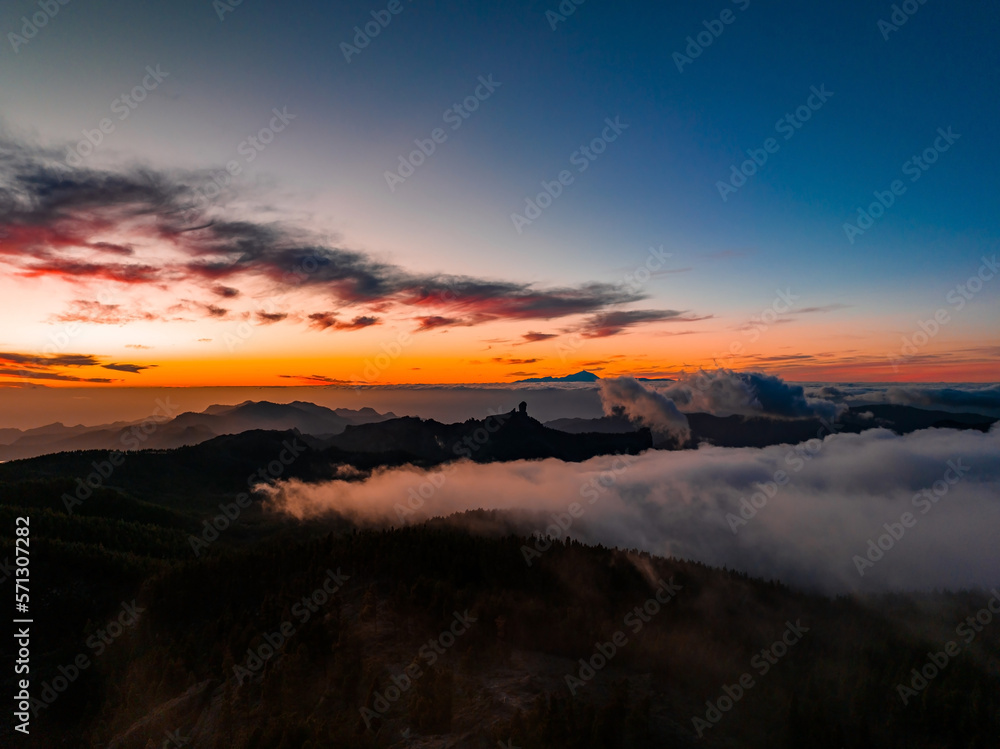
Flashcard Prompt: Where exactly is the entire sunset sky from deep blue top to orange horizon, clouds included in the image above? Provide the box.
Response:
[0,0,1000,388]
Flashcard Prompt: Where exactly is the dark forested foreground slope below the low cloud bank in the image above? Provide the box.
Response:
[0,424,1000,749]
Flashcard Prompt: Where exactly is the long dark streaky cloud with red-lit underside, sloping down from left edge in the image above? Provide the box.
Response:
[0,139,696,335]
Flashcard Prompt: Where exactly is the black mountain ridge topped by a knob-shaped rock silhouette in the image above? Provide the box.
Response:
[0,411,653,508]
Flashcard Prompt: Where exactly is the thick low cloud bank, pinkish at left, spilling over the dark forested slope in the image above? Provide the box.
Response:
[267,426,1000,592]
